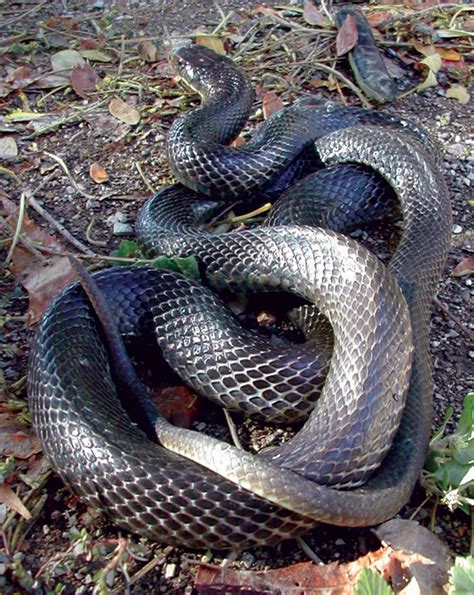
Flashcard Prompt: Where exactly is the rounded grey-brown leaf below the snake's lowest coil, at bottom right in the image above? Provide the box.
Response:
[375,519,452,595]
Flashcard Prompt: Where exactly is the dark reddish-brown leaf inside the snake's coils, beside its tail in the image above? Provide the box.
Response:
[152,386,203,428]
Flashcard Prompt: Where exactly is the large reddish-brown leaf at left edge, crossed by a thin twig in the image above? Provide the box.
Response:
[0,198,75,324]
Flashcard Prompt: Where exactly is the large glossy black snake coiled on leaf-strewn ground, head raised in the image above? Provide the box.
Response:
[28,46,451,549]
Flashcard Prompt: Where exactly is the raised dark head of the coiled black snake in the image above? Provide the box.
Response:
[170,45,234,95]
